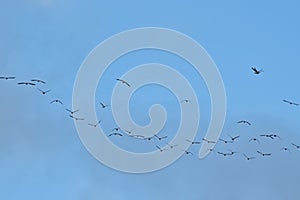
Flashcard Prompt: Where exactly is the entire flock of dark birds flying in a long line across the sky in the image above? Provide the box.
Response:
[0,67,300,161]
